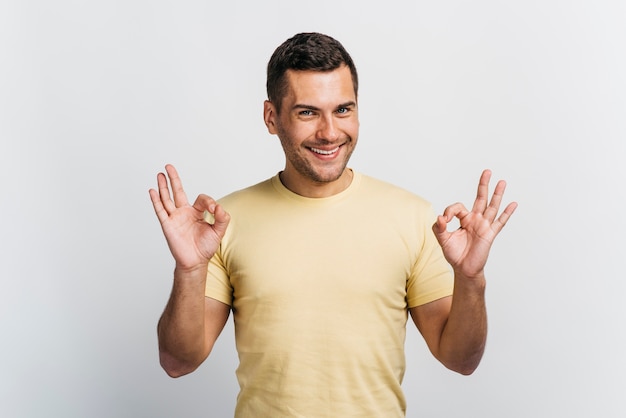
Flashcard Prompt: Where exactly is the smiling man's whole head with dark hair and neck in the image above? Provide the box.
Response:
[263,33,359,197]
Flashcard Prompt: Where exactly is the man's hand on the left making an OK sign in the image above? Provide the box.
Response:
[149,164,230,271]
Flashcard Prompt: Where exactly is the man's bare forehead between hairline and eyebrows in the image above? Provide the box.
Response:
[283,65,356,107]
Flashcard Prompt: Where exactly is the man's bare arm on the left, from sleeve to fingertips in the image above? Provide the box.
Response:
[150,165,230,377]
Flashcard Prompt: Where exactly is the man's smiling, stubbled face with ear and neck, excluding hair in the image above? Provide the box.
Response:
[264,66,359,197]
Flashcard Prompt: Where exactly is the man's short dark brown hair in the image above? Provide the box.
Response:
[266,32,359,112]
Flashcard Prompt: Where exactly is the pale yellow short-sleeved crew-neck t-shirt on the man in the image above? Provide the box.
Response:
[206,173,452,418]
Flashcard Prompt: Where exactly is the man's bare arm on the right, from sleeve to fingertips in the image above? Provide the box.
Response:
[410,170,517,374]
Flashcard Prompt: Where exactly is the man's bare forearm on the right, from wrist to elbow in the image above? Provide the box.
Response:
[439,275,487,374]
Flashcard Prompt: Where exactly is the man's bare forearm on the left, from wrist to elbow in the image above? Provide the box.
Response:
[157,265,208,377]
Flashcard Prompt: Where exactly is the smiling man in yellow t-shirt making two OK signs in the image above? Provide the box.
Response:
[150,33,517,418]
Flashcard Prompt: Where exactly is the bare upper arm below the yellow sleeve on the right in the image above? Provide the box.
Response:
[409,296,452,358]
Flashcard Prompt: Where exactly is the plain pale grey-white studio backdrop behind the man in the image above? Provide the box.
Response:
[0,0,626,418]
